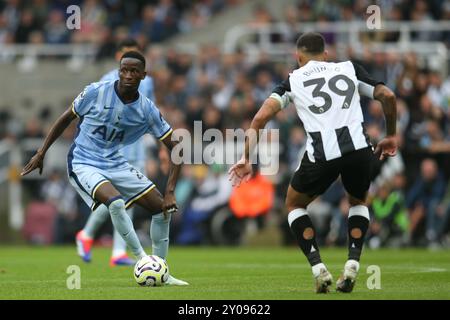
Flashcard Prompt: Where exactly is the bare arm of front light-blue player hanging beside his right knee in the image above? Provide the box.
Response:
[162,134,181,215]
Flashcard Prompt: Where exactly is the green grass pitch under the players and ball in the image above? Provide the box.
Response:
[0,246,450,300]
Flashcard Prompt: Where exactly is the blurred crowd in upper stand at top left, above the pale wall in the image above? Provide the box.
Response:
[0,0,242,48]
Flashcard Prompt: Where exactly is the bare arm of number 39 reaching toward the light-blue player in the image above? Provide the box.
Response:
[228,98,281,186]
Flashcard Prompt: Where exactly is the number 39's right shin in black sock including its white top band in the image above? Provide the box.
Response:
[348,205,370,261]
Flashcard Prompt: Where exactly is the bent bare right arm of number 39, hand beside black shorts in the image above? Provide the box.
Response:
[373,84,397,160]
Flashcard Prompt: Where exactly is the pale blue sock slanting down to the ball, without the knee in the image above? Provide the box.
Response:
[107,197,146,258]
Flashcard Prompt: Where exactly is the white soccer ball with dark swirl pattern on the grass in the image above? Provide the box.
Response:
[134,255,169,287]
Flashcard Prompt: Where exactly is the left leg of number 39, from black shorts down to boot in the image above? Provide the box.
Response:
[286,154,337,293]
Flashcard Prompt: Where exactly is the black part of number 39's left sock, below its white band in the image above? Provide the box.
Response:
[291,215,322,266]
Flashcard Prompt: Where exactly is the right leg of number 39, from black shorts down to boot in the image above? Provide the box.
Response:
[336,148,373,292]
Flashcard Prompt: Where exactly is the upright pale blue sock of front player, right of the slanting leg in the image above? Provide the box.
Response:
[150,213,171,259]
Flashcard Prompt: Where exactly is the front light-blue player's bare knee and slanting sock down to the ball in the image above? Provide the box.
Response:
[93,182,146,258]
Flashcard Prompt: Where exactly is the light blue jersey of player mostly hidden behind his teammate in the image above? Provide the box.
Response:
[100,69,155,170]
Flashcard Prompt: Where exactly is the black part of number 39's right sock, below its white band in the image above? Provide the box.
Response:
[348,215,369,261]
